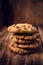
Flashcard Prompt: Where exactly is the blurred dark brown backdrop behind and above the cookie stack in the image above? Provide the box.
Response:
[0,0,43,26]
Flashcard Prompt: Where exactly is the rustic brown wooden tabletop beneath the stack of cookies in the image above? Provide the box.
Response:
[0,28,43,65]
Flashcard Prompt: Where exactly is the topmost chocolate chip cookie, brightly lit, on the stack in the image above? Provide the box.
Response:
[8,23,37,34]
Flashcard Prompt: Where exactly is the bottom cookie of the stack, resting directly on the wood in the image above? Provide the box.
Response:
[10,47,33,55]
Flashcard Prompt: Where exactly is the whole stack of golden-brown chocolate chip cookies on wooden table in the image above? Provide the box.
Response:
[8,24,41,54]
